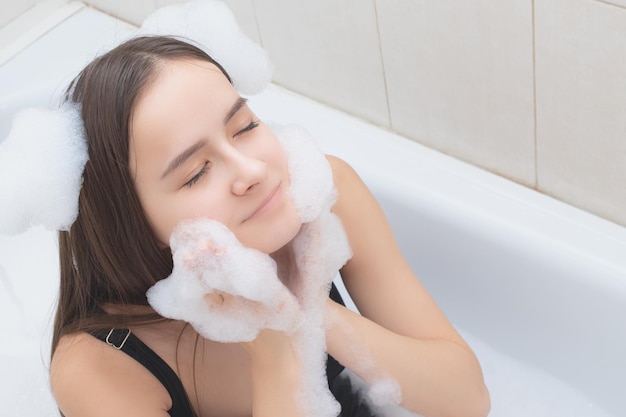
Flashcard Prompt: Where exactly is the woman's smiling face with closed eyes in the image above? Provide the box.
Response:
[130,60,301,253]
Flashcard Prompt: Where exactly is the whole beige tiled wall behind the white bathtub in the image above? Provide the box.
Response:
[0,0,626,225]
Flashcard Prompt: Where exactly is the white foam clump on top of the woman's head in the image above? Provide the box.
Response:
[139,0,272,94]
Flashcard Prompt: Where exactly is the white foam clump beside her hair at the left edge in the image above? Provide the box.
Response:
[0,106,88,234]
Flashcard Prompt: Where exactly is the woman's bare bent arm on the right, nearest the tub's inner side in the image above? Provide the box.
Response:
[327,157,489,417]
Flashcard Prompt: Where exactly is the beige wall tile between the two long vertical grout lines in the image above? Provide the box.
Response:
[376,0,535,186]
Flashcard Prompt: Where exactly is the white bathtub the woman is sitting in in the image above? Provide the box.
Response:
[0,6,626,417]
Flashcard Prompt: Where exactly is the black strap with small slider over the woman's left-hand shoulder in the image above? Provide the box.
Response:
[91,329,195,417]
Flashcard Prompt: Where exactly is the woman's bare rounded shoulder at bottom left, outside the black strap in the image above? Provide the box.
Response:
[50,333,171,417]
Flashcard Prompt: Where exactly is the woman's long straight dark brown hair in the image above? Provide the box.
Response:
[52,36,232,354]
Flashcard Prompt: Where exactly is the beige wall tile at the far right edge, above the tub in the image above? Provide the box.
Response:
[535,0,626,228]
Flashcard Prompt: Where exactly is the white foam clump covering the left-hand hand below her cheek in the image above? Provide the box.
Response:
[147,219,299,342]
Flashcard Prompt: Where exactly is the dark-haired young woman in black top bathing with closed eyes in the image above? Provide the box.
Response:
[50,37,489,417]
